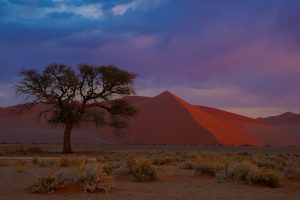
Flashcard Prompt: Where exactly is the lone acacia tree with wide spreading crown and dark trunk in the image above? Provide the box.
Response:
[16,64,137,153]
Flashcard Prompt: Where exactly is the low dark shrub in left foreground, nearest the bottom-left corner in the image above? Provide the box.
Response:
[29,175,63,193]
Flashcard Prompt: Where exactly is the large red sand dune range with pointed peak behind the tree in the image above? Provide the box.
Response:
[0,92,300,145]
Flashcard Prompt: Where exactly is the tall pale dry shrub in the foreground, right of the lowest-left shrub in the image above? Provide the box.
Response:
[79,163,114,192]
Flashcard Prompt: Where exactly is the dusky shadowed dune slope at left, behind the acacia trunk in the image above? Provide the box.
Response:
[0,105,106,144]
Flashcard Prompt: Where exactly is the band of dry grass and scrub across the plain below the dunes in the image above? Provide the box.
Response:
[0,145,300,199]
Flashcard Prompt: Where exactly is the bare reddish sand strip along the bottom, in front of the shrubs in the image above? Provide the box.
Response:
[0,168,300,200]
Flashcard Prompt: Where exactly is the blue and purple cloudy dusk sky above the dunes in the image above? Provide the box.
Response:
[0,0,300,117]
